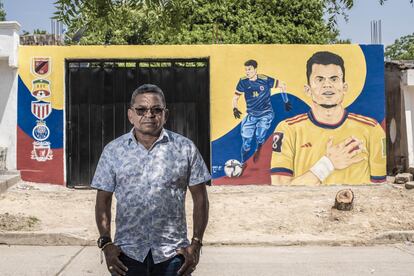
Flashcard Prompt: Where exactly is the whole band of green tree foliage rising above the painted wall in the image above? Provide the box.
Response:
[54,0,412,44]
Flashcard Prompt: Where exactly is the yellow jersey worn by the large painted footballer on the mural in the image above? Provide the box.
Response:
[271,111,386,184]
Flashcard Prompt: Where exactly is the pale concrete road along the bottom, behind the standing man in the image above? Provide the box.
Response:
[0,244,414,276]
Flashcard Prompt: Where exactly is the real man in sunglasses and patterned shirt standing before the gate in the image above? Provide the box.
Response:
[91,84,211,275]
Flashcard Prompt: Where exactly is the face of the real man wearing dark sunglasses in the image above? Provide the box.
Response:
[128,93,168,136]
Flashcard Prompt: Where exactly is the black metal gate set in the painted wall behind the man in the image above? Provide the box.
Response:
[66,59,210,187]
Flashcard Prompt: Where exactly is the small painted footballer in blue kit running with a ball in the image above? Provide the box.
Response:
[233,60,291,168]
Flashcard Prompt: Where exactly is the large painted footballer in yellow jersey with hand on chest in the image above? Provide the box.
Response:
[271,52,386,184]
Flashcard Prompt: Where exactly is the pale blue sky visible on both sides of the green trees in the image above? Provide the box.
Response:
[2,0,414,46]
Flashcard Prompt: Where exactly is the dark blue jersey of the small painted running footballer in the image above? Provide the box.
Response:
[236,75,277,116]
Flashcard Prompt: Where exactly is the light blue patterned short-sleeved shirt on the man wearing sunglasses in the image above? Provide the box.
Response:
[91,130,211,263]
